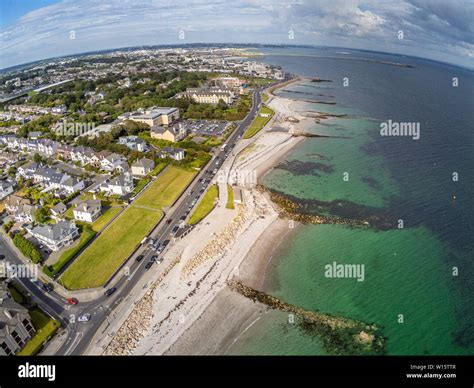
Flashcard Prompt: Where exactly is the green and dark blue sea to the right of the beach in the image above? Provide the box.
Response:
[227,47,474,355]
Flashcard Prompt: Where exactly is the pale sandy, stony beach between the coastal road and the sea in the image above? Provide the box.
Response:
[104,78,314,355]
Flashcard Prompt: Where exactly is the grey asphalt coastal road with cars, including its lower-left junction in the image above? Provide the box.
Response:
[0,81,278,355]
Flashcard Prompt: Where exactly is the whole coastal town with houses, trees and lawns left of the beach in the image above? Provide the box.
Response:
[0,44,287,354]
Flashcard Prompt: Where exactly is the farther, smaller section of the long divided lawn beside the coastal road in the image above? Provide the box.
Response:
[134,166,196,209]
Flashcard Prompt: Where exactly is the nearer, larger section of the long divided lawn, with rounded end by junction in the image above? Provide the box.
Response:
[60,205,163,290]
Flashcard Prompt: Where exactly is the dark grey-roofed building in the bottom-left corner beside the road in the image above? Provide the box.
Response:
[0,282,35,356]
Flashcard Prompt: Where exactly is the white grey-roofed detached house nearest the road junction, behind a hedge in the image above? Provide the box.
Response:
[26,221,79,251]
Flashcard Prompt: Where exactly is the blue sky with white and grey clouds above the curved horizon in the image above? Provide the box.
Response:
[0,0,474,68]
